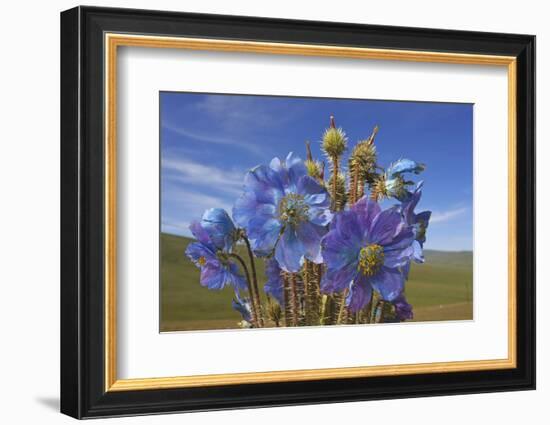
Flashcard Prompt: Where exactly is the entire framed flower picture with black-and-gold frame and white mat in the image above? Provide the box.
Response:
[61,7,535,418]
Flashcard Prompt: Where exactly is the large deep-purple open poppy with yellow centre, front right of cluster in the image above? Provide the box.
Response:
[321,197,415,312]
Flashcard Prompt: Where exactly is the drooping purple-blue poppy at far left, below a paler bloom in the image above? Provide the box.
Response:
[185,222,247,290]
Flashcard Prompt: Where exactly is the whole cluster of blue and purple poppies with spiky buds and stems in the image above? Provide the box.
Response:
[186,117,431,327]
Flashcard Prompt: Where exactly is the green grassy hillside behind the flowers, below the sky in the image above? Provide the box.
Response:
[160,233,472,331]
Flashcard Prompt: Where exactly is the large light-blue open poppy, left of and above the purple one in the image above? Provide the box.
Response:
[233,152,332,272]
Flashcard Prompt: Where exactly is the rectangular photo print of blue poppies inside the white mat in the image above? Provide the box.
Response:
[159,92,473,332]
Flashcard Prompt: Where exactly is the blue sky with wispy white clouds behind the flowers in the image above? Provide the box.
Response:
[160,92,473,250]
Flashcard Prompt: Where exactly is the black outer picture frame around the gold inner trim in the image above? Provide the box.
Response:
[61,7,535,418]
